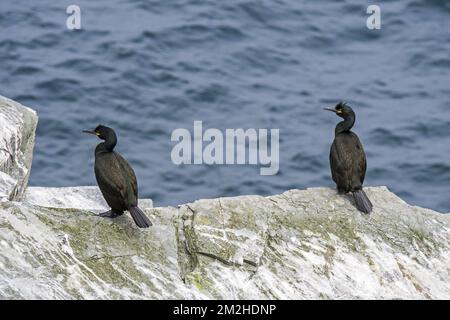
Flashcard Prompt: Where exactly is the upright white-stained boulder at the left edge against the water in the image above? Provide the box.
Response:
[0,96,37,201]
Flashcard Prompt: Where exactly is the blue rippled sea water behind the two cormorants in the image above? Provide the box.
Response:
[0,0,450,212]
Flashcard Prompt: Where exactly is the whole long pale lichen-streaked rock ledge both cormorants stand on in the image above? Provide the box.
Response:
[0,187,450,299]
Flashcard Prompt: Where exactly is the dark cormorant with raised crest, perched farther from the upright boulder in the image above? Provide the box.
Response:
[325,102,372,213]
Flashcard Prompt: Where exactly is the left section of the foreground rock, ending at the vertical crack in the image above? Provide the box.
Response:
[0,202,186,299]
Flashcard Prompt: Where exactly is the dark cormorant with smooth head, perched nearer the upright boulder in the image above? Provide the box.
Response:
[83,125,152,228]
